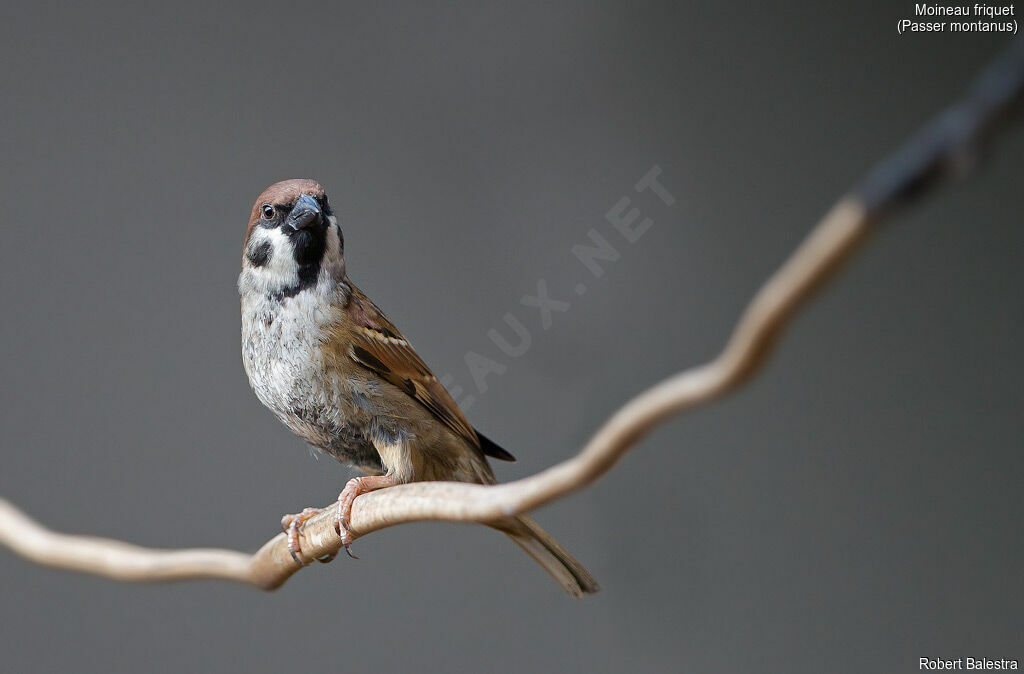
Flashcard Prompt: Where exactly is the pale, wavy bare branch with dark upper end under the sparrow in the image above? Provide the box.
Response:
[0,38,1024,590]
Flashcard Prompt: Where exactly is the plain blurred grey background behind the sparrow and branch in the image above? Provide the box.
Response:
[0,1,1024,672]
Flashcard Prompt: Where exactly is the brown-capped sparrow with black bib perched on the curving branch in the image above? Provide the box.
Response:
[239,179,598,596]
